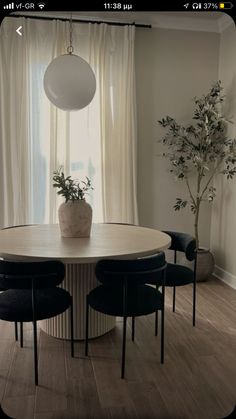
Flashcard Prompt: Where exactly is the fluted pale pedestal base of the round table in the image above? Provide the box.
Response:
[40,263,116,340]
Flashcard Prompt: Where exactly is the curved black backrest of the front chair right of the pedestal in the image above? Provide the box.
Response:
[95,252,166,286]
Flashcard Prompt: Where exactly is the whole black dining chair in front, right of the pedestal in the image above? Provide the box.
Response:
[85,252,166,378]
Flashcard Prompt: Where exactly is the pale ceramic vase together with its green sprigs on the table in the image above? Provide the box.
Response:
[53,168,93,237]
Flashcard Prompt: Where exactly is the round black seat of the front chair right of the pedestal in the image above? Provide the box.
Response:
[88,285,162,317]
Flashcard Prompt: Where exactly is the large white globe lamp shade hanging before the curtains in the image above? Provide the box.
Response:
[43,54,96,111]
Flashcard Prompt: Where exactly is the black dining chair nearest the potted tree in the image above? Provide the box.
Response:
[149,231,197,328]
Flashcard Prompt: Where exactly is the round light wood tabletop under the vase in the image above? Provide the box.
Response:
[0,223,171,263]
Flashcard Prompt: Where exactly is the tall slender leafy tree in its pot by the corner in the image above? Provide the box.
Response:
[158,80,236,280]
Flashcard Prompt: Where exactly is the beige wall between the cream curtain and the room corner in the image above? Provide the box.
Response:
[136,28,219,249]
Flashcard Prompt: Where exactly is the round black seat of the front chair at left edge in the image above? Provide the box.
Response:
[0,288,71,322]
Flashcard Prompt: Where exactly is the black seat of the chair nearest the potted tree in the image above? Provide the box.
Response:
[165,263,194,287]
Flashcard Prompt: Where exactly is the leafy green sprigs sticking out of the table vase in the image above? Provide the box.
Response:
[52,167,93,202]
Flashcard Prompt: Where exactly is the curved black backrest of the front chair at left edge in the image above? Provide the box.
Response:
[0,260,65,289]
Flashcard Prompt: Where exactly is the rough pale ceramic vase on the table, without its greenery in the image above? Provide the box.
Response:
[58,199,92,237]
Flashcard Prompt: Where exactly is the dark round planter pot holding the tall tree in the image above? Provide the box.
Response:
[196,248,215,282]
